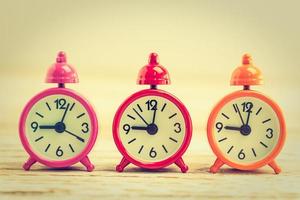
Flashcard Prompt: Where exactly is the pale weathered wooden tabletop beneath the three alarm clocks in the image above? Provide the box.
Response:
[0,124,300,200]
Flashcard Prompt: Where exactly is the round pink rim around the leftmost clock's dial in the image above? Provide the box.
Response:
[19,88,98,168]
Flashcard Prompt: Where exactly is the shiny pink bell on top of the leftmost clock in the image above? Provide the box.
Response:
[46,51,79,84]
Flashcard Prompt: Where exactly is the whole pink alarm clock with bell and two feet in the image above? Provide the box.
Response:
[19,52,98,171]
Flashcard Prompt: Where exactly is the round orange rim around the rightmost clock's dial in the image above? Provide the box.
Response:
[207,90,286,170]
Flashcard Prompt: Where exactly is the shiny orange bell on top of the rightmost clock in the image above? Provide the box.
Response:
[230,54,263,86]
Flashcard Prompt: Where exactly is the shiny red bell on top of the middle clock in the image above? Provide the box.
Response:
[137,53,171,85]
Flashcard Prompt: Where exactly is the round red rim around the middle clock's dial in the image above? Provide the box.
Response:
[112,89,193,169]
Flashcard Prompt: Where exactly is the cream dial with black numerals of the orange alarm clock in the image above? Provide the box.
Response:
[212,97,280,165]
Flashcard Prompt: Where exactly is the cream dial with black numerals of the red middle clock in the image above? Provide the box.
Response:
[119,96,186,163]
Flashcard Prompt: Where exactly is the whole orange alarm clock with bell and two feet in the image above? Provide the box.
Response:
[207,54,286,174]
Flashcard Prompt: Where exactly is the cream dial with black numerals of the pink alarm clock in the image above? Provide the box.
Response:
[25,94,92,161]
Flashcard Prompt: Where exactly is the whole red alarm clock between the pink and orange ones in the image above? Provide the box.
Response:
[112,53,192,173]
